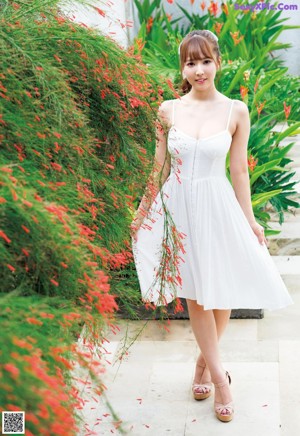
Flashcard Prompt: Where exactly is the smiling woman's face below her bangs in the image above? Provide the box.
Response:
[182,58,217,91]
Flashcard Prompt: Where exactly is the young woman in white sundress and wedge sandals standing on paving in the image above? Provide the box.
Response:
[131,30,292,421]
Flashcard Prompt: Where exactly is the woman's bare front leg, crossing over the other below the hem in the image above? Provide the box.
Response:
[186,299,232,404]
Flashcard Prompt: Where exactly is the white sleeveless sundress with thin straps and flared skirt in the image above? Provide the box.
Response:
[132,100,293,310]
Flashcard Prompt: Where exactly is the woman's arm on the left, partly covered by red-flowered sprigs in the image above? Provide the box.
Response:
[134,101,171,230]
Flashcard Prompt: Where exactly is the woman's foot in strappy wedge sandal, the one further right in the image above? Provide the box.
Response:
[214,371,234,422]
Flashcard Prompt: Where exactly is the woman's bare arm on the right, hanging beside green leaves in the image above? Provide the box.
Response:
[230,100,267,244]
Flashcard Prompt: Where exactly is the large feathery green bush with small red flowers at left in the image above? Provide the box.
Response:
[0,0,175,436]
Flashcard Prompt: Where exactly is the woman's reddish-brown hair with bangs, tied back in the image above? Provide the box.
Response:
[179,30,221,94]
